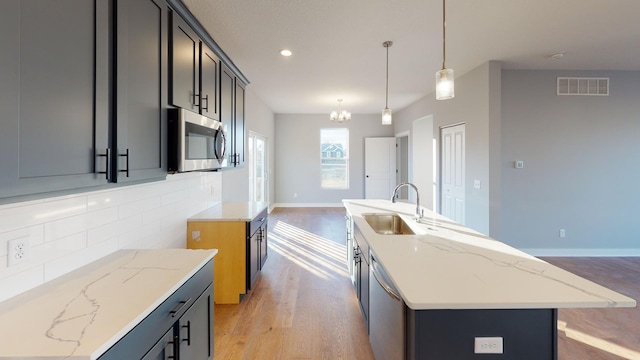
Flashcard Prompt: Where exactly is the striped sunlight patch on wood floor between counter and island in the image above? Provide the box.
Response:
[268,220,349,279]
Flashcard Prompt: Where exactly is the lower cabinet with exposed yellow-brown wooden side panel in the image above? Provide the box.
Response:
[187,208,267,304]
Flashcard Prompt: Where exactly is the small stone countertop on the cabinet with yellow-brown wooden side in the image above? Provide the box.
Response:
[187,201,269,221]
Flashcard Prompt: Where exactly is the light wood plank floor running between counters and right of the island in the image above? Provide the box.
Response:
[214,208,640,360]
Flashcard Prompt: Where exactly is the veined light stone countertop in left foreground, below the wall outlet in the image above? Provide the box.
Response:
[0,249,218,360]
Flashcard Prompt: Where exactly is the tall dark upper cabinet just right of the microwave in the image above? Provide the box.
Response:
[220,64,246,167]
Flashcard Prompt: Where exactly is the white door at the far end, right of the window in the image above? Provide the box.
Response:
[364,137,396,199]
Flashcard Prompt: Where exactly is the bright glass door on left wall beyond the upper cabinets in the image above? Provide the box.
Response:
[248,132,269,201]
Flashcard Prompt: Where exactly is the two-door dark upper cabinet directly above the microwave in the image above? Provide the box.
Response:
[170,12,220,120]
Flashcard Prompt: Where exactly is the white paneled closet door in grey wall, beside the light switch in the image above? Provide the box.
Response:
[440,124,465,224]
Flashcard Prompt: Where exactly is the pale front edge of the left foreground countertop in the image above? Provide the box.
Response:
[87,249,218,360]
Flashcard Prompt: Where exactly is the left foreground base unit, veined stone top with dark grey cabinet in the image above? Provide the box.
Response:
[0,249,217,360]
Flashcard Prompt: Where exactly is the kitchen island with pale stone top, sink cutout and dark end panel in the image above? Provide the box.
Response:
[343,200,636,359]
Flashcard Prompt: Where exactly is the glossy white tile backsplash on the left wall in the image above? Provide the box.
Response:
[0,172,222,301]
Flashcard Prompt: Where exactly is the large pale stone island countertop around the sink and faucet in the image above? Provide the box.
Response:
[343,199,636,310]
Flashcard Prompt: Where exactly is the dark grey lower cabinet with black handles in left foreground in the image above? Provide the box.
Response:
[98,260,214,360]
